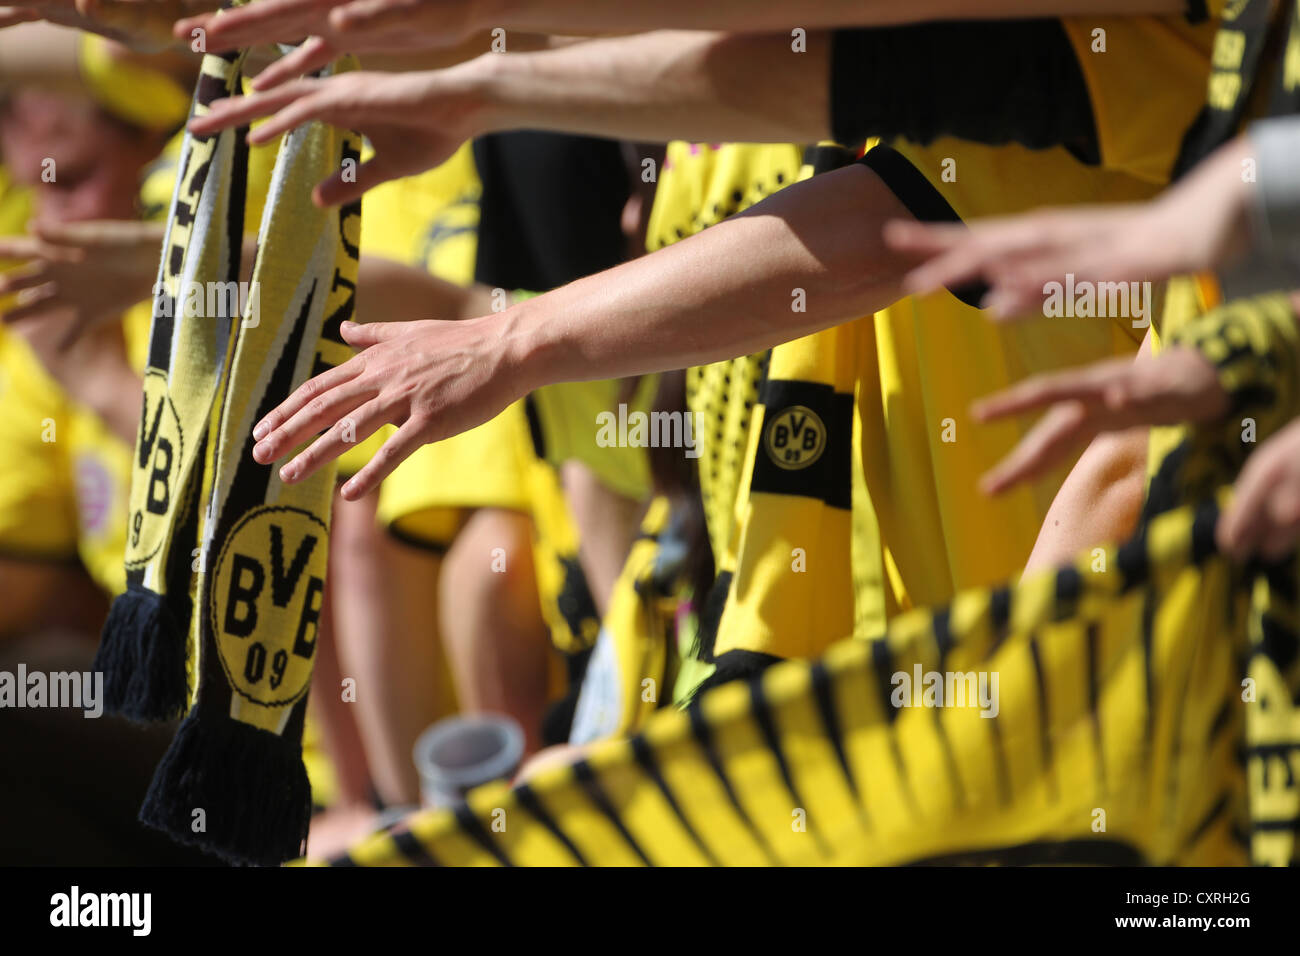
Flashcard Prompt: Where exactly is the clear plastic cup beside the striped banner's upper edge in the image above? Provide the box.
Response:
[415,714,524,806]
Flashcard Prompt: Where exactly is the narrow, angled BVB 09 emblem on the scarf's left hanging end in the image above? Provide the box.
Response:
[126,368,185,566]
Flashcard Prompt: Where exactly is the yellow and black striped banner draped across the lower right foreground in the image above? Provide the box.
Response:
[319,501,1300,866]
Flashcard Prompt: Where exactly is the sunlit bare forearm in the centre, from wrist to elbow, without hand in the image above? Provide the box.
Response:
[498,166,909,388]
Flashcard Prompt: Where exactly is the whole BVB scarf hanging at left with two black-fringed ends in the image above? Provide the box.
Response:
[96,1,360,864]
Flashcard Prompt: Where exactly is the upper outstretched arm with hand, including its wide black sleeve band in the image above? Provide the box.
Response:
[190,11,1100,204]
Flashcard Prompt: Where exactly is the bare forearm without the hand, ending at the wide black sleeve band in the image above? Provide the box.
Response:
[465,31,831,143]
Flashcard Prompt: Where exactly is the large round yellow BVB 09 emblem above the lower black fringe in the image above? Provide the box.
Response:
[211,506,329,706]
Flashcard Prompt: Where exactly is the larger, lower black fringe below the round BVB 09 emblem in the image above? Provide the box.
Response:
[140,709,312,866]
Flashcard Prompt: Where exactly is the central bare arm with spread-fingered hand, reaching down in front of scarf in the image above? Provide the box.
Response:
[254,159,909,498]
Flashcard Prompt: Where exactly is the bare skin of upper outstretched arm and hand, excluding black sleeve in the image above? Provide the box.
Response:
[190,31,831,204]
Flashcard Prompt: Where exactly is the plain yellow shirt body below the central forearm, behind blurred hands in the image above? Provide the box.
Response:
[858,283,1138,609]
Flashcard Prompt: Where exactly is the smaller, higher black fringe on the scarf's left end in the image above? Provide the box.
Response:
[92,584,190,722]
